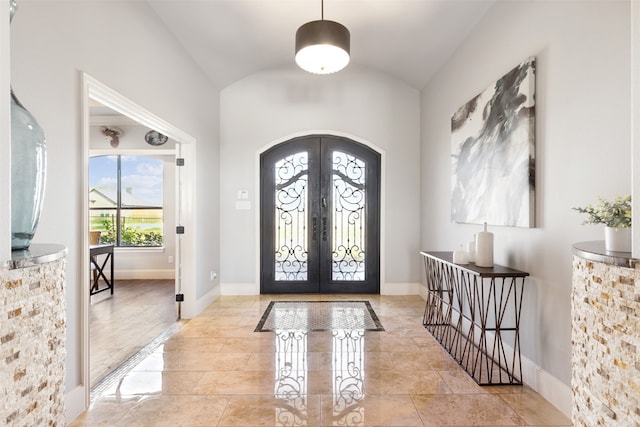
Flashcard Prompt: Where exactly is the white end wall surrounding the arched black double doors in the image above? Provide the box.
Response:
[220,66,420,293]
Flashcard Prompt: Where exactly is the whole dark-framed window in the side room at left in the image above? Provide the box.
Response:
[89,155,163,247]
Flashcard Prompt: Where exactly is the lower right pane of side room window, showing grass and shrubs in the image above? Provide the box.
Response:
[120,209,162,246]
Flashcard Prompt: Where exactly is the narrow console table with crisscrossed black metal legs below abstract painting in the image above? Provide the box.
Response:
[420,251,529,385]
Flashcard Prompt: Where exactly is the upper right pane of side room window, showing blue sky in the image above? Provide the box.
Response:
[120,156,162,208]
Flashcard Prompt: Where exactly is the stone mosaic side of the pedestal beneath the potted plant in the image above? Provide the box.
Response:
[571,256,640,427]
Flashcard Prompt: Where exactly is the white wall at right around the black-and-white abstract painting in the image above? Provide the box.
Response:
[421,1,631,412]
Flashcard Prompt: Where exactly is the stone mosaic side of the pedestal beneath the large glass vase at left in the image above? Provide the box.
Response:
[0,258,66,426]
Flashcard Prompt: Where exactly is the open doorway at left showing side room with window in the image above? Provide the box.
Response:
[88,111,180,397]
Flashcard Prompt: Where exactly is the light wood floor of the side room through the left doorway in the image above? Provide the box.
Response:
[89,280,176,386]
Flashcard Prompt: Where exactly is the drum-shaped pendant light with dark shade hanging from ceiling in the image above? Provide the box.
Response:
[296,0,351,74]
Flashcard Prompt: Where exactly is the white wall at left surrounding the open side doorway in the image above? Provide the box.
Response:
[11,0,219,416]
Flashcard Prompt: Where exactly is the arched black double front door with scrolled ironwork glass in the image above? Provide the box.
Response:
[260,135,380,293]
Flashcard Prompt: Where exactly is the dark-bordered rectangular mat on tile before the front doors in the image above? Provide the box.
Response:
[254,301,384,332]
